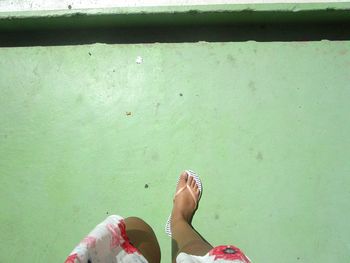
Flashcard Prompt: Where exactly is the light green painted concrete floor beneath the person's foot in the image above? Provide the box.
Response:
[0,41,350,263]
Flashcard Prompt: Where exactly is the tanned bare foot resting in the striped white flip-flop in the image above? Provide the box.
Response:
[171,172,200,225]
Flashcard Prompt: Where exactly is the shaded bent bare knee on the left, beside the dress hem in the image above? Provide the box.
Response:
[125,217,160,263]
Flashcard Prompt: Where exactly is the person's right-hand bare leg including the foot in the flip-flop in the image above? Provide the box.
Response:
[171,172,213,262]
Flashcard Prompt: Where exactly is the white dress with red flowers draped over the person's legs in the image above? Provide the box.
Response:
[65,215,250,263]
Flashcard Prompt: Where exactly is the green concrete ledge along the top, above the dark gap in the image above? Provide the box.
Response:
[0,3,350,31]
